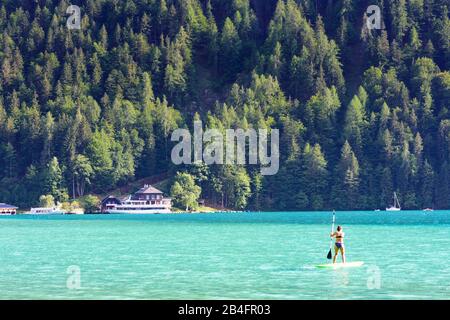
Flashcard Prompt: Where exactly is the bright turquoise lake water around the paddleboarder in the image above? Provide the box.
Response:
[0,211,450,299]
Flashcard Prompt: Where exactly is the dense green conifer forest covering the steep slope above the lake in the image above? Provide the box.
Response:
[0,0,450,210]
